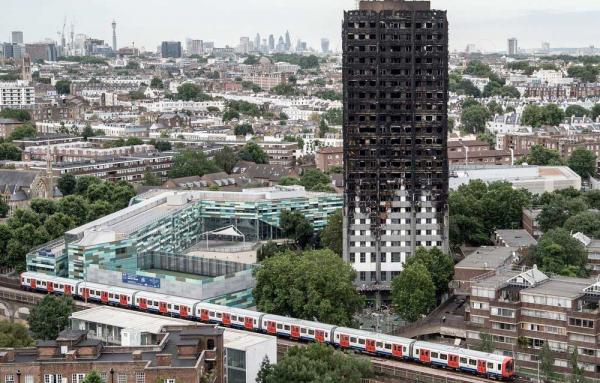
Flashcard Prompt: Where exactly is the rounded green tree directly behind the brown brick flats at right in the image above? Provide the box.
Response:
[534,228,587,276]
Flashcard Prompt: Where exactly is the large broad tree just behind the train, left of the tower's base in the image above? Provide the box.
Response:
[253,250,363,326]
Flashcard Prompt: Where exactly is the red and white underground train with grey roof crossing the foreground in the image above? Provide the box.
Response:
[20,272,515,380]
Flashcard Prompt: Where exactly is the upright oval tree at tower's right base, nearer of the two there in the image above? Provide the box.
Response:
[391,262,435,322]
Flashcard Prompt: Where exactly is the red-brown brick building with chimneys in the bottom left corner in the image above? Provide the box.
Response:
[0,326,224,383]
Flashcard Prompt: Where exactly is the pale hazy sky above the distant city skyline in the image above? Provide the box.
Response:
[0,0,600,50]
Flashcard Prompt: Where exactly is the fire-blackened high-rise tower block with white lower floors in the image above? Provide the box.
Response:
[342,0,448,297]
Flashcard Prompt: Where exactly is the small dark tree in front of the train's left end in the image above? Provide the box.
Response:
[27,295,73,340]
